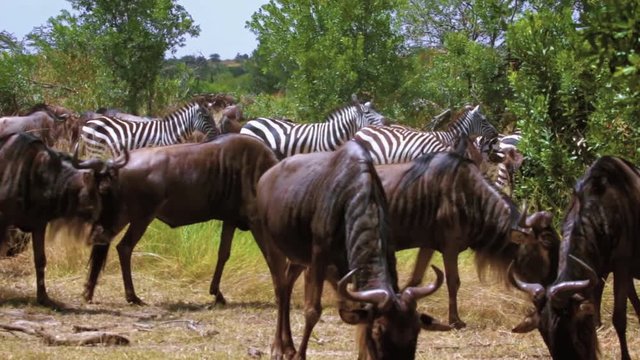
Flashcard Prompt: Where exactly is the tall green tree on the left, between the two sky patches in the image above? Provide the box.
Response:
[51,0,200,113]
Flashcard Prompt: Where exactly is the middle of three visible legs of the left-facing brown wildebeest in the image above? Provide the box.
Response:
[116,217,153,305]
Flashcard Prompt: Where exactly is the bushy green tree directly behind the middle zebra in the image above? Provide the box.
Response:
[247,0,404,120]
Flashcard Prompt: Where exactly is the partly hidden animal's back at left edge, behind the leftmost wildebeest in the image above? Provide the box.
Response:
[0,104,68,146]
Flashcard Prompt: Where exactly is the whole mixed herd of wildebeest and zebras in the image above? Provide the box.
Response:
[0,94,640,359]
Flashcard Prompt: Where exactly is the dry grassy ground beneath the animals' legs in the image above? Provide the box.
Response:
[0,222,640,359]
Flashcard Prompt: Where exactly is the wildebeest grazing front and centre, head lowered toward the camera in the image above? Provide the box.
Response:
[252,141,442,359]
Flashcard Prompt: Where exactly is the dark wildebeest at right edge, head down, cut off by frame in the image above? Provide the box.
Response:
[514,156,640,359]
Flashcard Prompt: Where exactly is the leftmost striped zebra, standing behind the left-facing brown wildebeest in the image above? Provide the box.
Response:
[82,101,217,157]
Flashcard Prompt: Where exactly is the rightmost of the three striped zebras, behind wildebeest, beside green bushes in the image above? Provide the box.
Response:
[354,106,498,164]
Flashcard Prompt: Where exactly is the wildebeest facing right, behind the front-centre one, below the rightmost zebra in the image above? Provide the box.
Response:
[376,141,559,328]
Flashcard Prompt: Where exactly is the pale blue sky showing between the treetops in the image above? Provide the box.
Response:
[0,0,269,59]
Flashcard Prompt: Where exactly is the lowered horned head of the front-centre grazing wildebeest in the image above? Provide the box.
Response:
[338,266,451,359]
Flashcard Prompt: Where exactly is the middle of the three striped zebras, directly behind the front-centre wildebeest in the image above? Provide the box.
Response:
[240,97,385,159]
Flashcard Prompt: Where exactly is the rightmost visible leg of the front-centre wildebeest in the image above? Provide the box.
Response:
[296,256,327,359]
